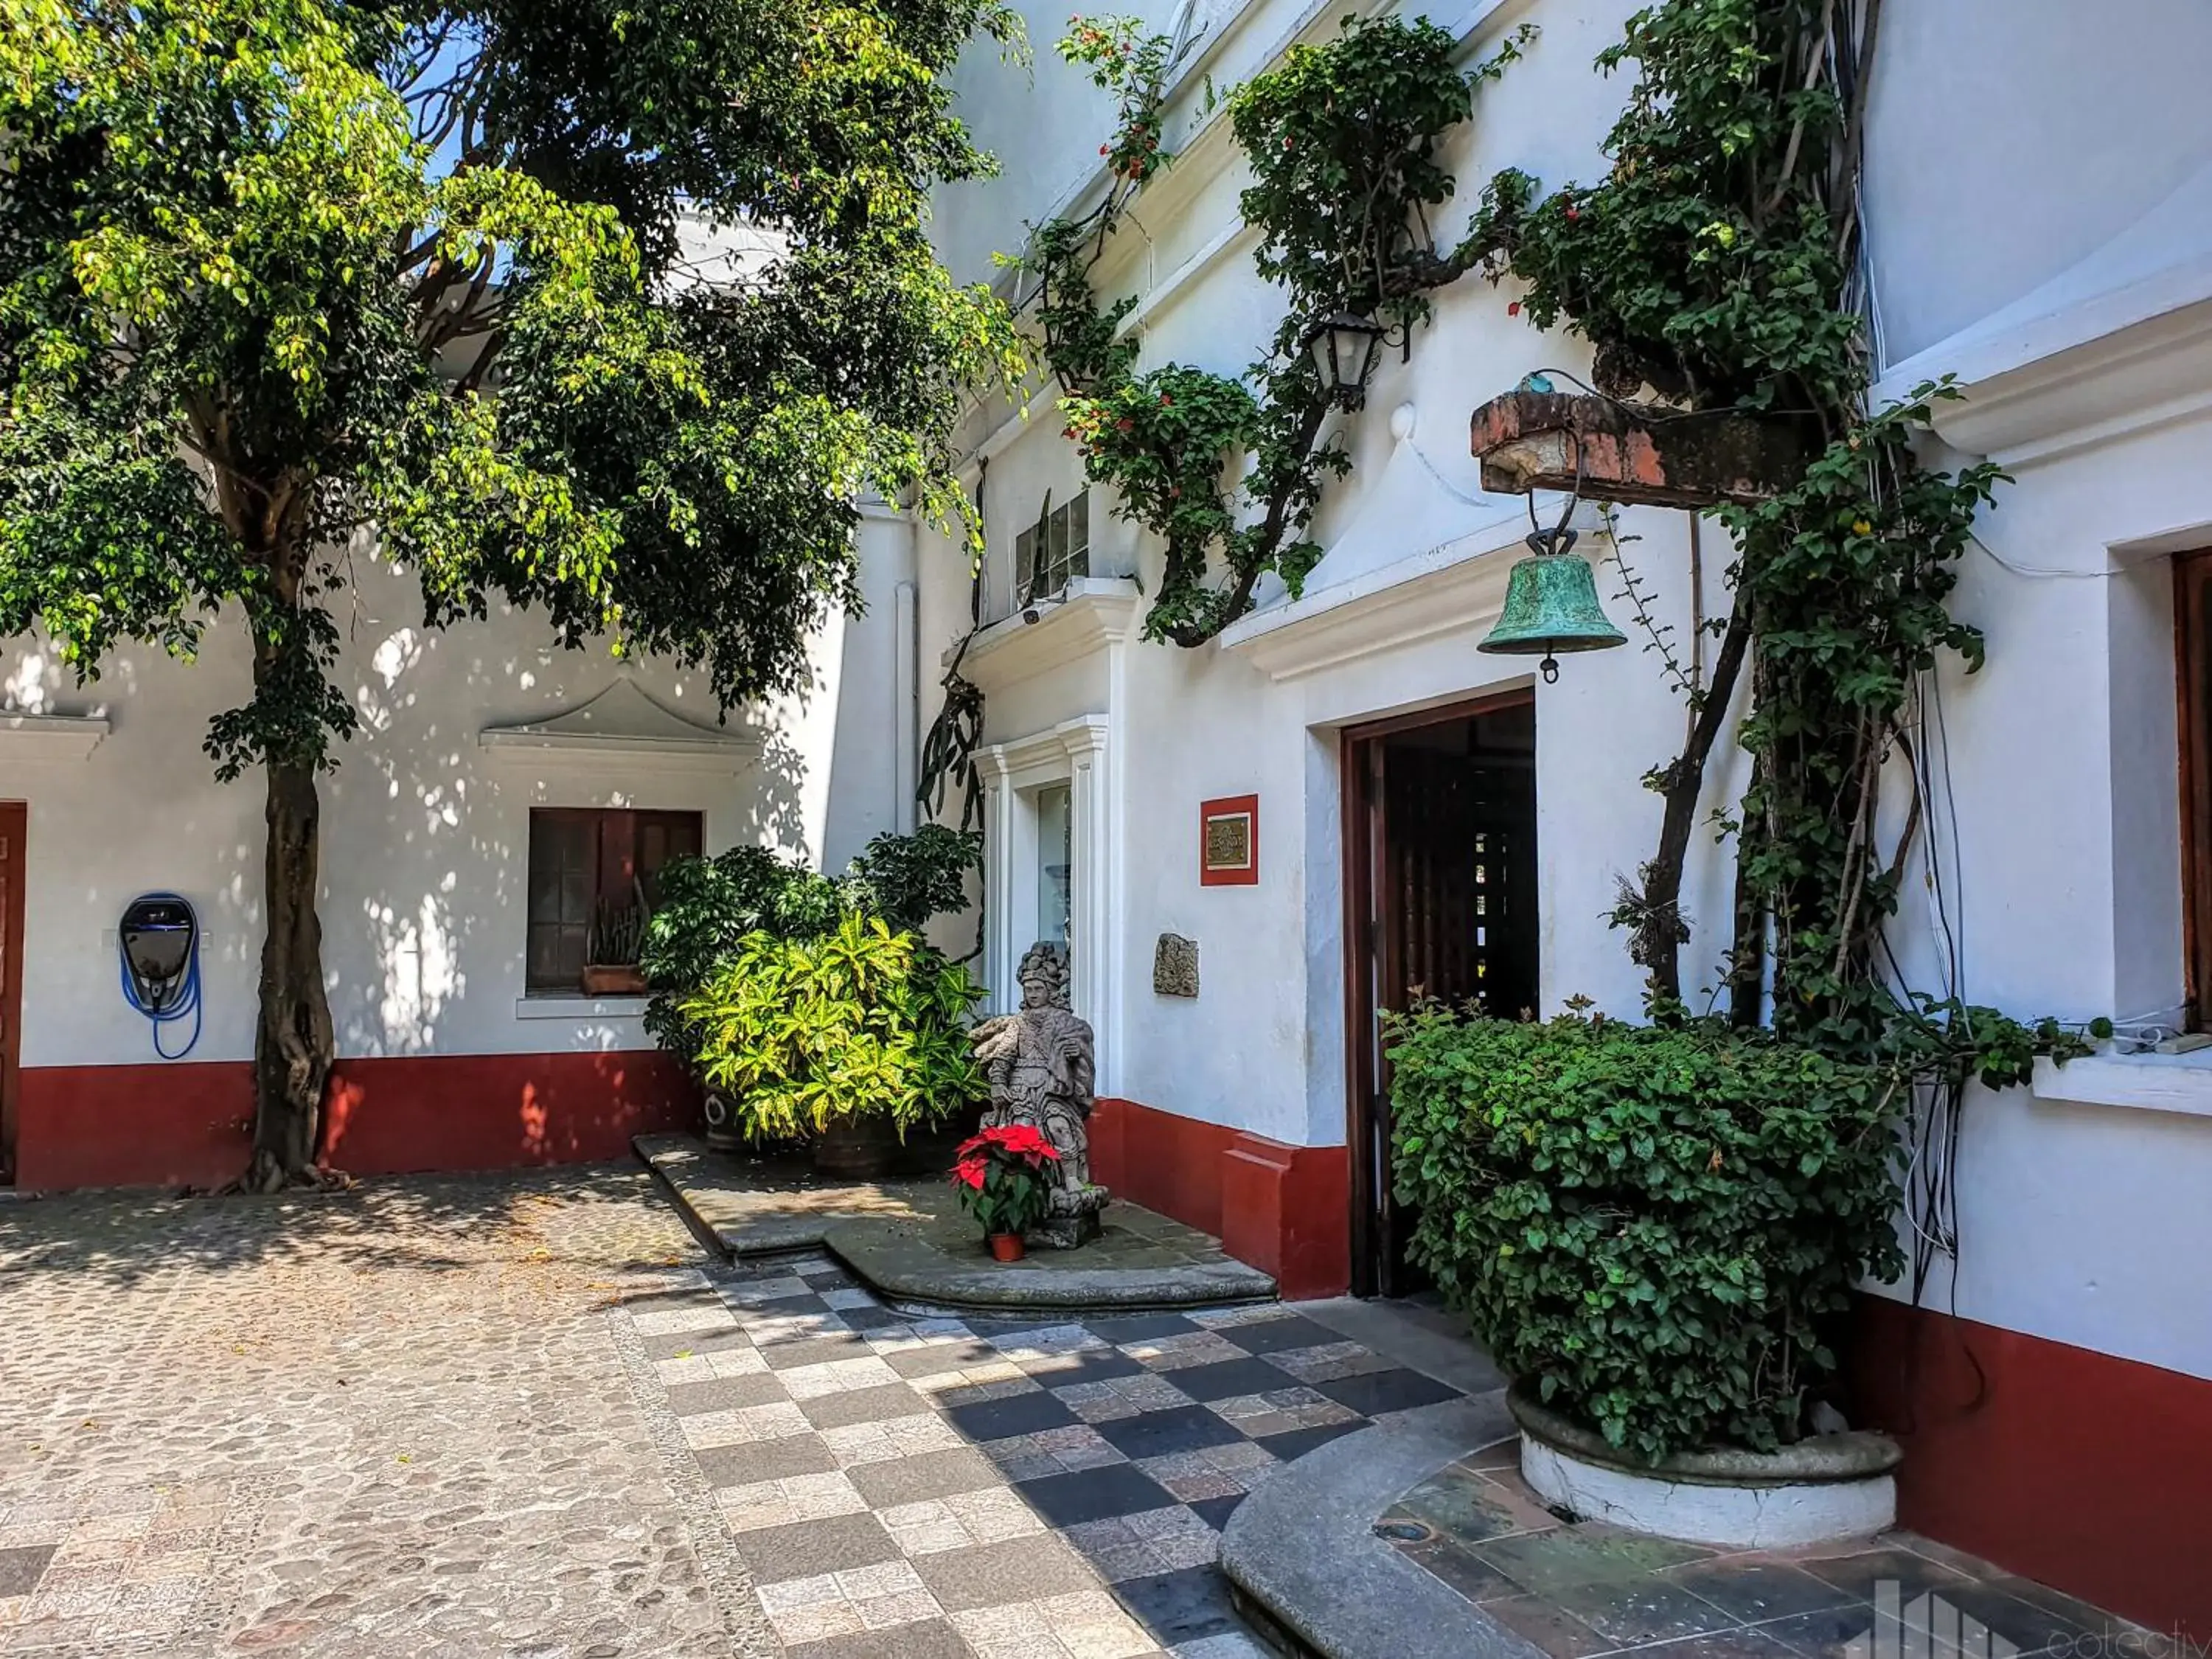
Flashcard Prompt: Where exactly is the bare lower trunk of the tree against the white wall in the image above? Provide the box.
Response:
[246,761,336,1192]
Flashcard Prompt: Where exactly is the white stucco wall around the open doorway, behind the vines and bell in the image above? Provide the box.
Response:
[925,0,2212,1378]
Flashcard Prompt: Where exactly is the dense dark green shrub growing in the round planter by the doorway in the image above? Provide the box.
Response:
[1387,1009,1905,1462]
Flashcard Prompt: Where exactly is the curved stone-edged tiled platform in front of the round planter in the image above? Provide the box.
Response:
[1221,1391,2161,1659]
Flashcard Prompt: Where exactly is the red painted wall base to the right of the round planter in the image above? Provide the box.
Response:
[1851,1296,2212,1641]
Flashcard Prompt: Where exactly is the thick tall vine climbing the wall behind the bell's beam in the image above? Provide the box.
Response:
[1460,0,2070,1082]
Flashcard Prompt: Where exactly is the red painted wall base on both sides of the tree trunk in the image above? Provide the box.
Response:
[15,1048,697,1192]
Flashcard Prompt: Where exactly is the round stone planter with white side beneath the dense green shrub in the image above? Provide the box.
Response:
[1506,1387,1905,1548]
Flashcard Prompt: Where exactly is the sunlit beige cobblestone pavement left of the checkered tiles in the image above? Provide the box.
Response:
[0,1170,774,1659]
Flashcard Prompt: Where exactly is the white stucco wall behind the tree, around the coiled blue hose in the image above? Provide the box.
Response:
[0,515,914,1066]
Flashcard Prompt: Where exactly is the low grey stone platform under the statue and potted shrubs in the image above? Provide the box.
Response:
[635,1135,1276,1312]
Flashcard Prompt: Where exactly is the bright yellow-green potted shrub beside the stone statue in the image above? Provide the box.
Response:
[675,914,989,1139]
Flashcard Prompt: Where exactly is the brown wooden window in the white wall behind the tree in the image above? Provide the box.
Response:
[524,807,701,995]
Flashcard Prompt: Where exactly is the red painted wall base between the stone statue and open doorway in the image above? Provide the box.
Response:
[1091,1097,1352,1298]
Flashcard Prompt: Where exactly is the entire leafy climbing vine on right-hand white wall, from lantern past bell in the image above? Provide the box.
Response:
[1018,0,2079,1084]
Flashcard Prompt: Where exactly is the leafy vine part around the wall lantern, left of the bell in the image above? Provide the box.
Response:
[1018,18,1533,646]
